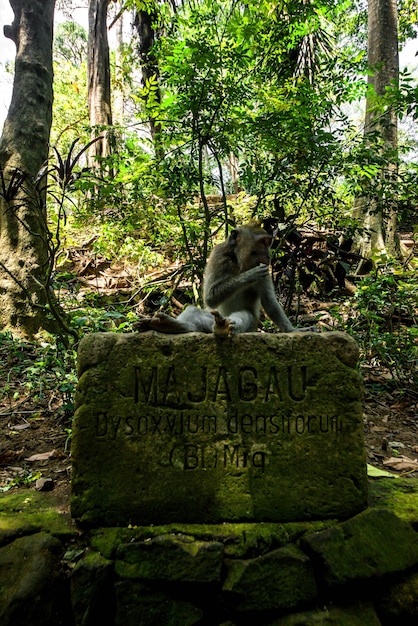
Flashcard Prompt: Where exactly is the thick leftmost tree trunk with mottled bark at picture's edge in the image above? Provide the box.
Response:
[0,0,55,336]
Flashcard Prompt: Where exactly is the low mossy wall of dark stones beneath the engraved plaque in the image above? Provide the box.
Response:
[0,478,418,626]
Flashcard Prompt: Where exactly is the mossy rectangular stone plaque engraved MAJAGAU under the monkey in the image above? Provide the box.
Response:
[71,331,367,525]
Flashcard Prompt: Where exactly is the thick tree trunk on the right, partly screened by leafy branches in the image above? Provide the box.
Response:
[359,0,399,266]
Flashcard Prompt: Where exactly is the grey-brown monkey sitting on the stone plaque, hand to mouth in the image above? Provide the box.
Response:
[135,224,312,337]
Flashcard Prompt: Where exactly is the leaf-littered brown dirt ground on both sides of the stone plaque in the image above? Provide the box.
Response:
[0,342,418,509]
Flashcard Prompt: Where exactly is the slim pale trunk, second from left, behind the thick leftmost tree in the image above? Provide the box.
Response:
[87,0,112,165]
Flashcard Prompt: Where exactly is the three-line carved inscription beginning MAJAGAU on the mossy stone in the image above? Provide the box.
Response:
[96,365,344,472]
